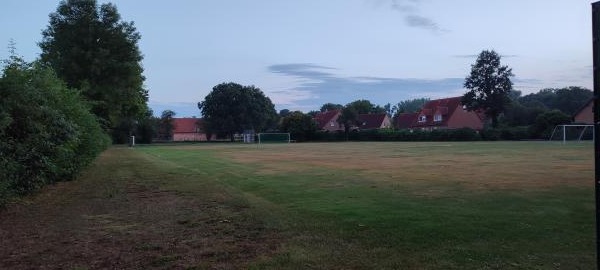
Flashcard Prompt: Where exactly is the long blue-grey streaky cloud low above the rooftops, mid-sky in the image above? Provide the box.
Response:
[267,63,464,111]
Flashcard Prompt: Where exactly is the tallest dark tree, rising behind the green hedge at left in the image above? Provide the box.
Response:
[39,0,148,142]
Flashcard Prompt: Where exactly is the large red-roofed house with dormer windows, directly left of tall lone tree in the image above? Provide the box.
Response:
[411,97,485,130]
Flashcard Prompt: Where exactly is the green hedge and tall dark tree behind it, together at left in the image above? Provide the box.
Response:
[0,0,153,206]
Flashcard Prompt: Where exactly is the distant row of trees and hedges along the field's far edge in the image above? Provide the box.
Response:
[193,50,592,141]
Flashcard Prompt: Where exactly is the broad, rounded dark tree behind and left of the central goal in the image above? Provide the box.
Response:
[198,82,277,140]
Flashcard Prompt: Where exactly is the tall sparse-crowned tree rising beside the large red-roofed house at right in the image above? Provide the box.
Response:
[461,50,513,127]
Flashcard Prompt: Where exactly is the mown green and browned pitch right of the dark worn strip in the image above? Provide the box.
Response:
[138,142,595,269]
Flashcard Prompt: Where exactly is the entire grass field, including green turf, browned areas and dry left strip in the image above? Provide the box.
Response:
[0,142,595,269]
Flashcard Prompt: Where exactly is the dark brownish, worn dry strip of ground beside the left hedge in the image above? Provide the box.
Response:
[0,149,281,269]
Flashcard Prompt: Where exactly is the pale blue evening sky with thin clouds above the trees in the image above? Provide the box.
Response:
[0,0,594,117]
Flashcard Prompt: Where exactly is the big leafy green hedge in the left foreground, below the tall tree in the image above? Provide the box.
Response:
[0,56,109,204]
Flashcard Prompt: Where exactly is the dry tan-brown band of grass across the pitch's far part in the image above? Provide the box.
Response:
[224,142,593,191]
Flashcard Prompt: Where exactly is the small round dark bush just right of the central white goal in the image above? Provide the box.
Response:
[279,111,317,142]
